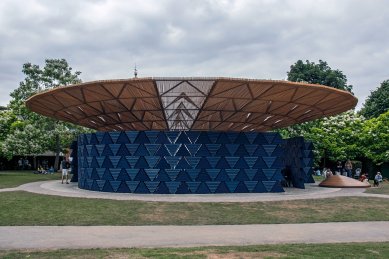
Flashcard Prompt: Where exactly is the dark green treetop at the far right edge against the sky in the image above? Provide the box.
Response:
[360,80,389,119]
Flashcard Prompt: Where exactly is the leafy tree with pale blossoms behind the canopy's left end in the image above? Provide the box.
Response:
[2,59,85,168]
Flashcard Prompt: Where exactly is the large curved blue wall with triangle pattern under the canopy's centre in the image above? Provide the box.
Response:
[78,131,292,194]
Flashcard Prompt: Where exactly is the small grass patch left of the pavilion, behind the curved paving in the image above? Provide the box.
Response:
[0,171,61,189]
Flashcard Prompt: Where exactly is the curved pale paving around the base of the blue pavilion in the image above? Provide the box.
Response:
[0,180,389,202]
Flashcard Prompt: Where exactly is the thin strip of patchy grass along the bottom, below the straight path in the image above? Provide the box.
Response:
[0,242,389,259]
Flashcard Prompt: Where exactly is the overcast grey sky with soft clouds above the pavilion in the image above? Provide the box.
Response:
[0,0,389,110]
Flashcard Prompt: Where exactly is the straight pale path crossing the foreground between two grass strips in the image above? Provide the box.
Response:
[0,222,389,250]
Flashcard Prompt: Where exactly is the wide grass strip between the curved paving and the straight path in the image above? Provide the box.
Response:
[0,191,389,226]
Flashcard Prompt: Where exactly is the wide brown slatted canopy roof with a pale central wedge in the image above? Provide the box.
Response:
[26,78,357,131]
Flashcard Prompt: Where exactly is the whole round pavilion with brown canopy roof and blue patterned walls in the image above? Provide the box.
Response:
[26,77,357,194]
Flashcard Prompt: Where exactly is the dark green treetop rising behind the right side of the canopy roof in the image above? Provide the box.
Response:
[287,60,353,92]
